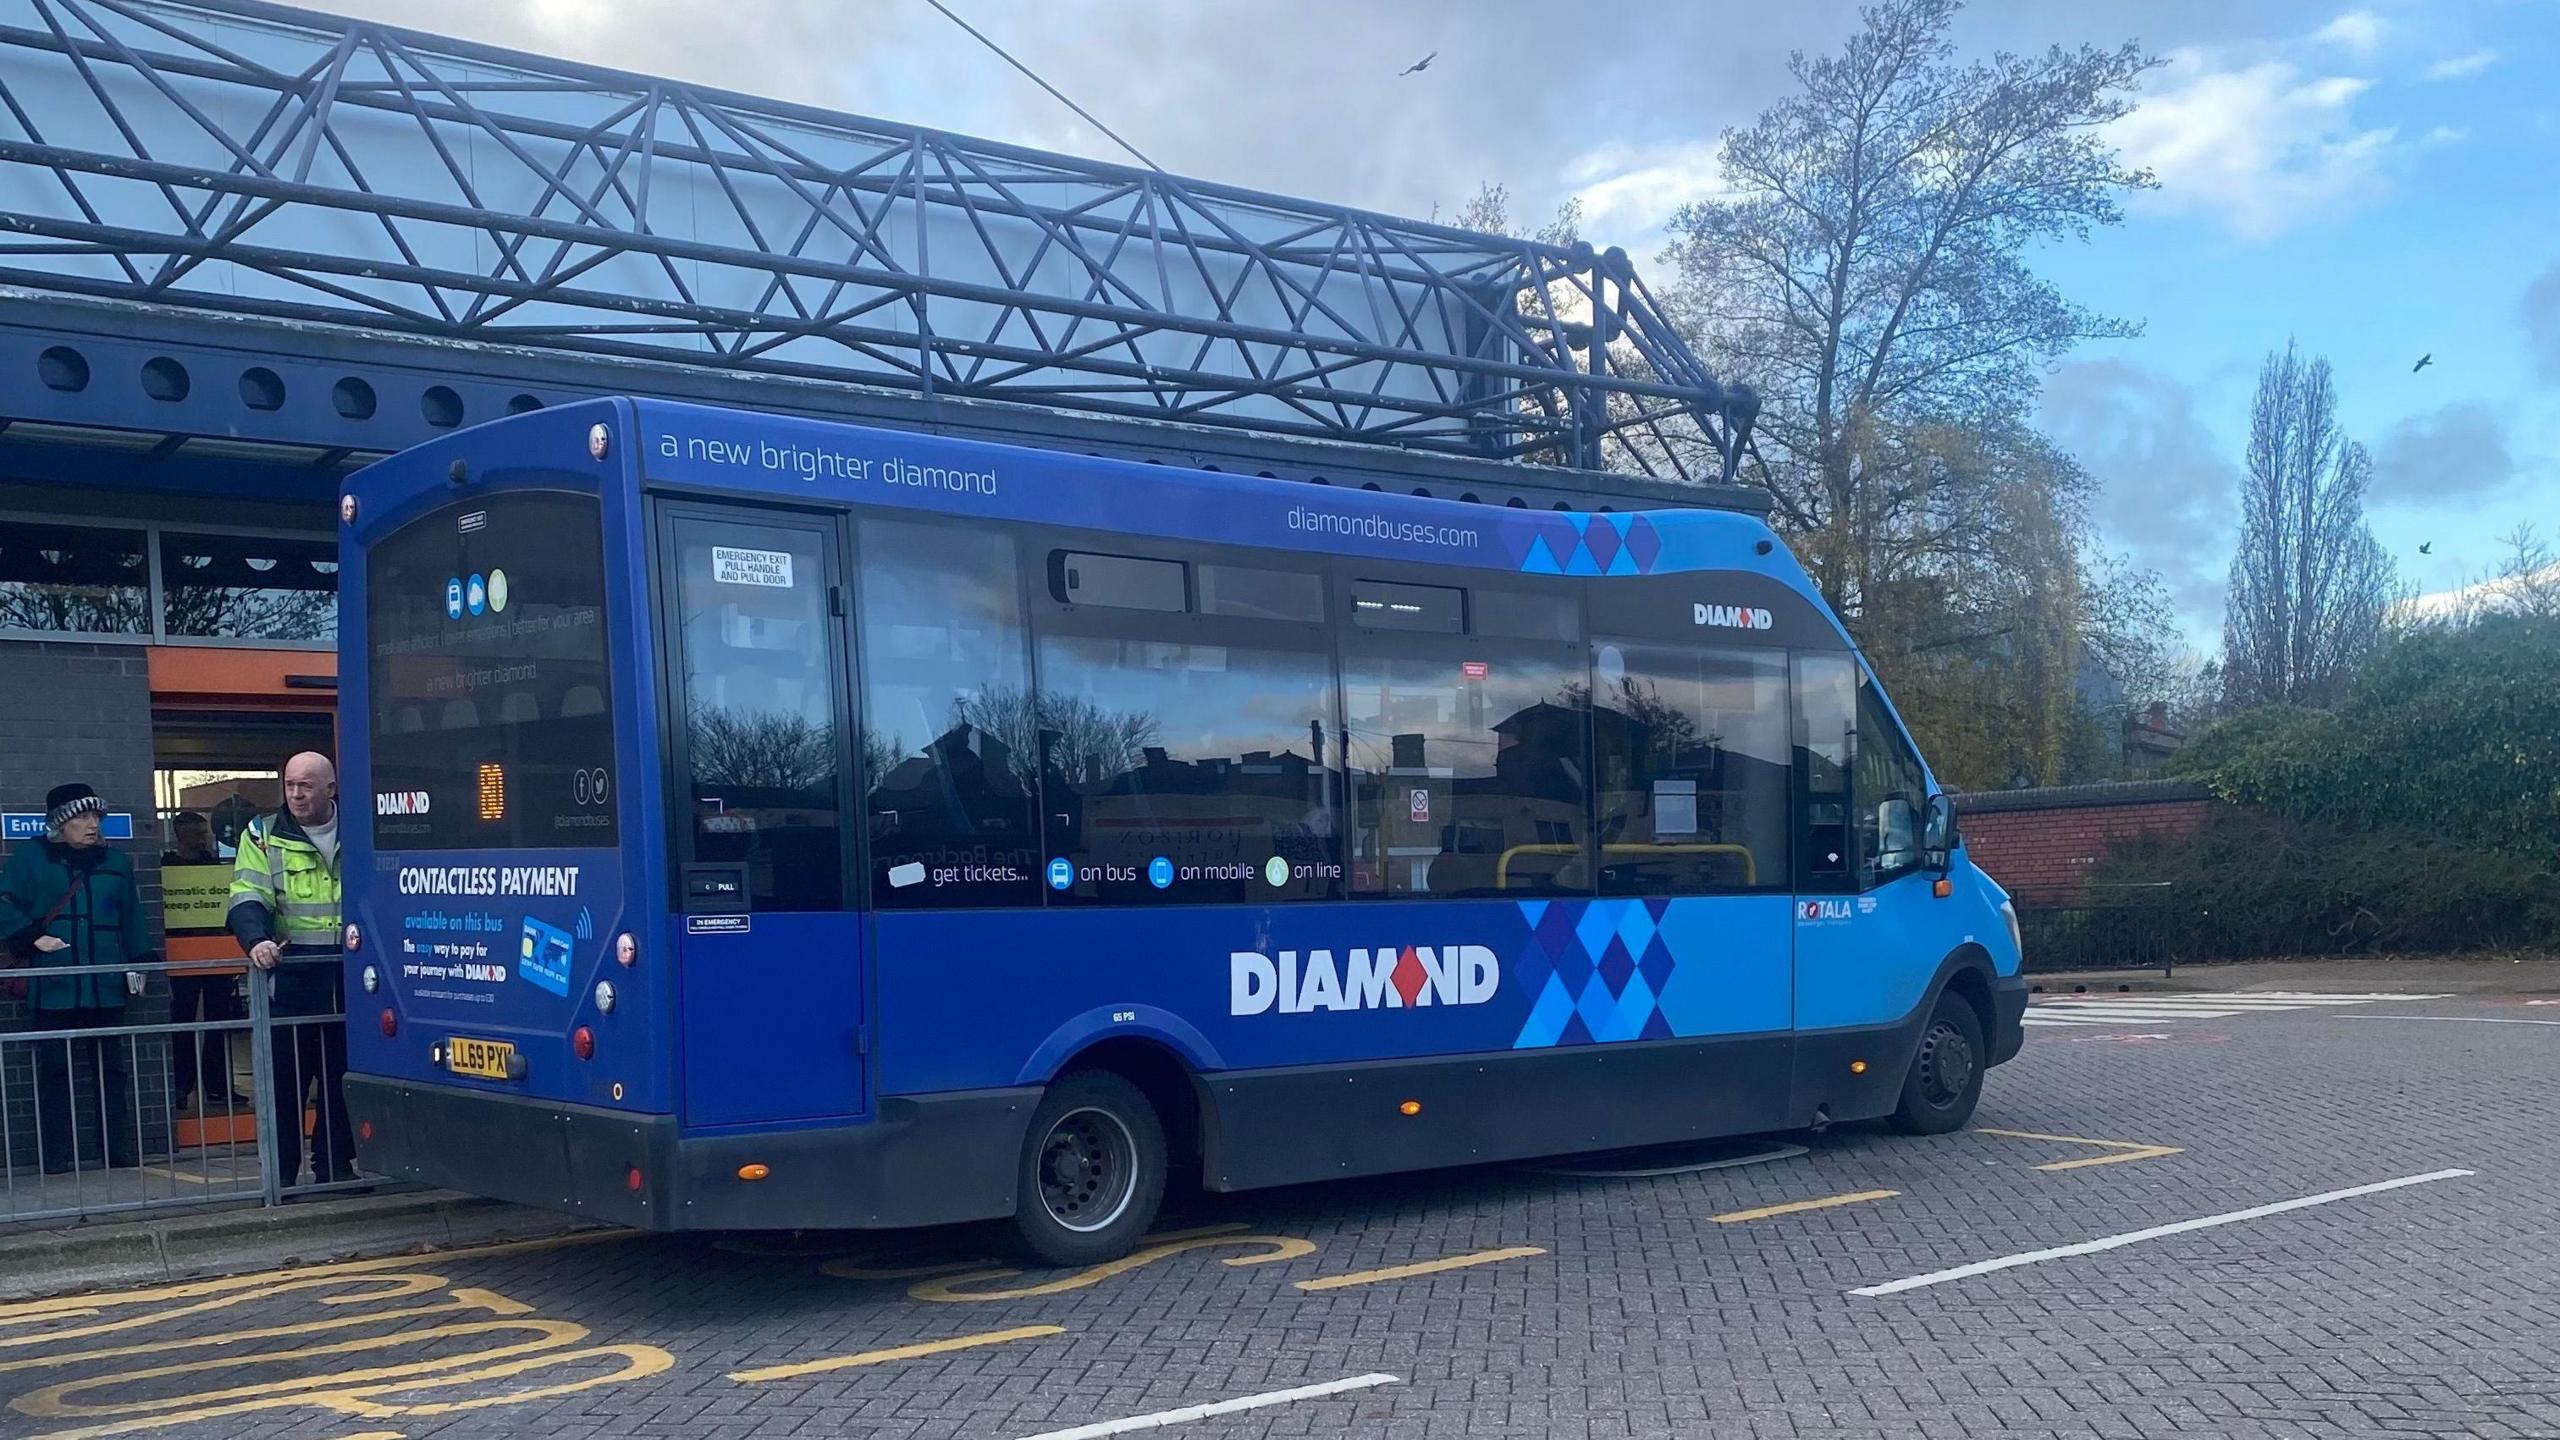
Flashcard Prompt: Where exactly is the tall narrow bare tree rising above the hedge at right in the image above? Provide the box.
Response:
[2222,341,2399,705]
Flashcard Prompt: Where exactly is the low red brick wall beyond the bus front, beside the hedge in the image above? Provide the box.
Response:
[1956,781,2214,904]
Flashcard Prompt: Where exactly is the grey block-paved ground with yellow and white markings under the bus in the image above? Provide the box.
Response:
[0,997,2560,1440]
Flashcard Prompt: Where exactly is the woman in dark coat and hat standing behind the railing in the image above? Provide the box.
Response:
[0,784,154,1176]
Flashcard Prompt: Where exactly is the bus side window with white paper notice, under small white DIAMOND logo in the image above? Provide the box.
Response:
[1592,641,1789,894]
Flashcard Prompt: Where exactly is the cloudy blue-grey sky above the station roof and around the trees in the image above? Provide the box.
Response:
[323,0,2560,638]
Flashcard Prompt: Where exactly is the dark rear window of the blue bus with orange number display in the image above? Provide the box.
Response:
[358,489,617,851]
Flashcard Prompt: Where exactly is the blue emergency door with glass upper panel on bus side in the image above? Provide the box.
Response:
[658,502,868,1125]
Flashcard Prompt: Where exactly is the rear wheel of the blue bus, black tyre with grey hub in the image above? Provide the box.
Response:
[1014,1071,1165,1266]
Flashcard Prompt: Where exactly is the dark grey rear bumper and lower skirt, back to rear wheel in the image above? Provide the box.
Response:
[346,1074,1039,1230]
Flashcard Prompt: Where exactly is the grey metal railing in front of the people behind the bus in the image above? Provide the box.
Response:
[0,956,374,1225]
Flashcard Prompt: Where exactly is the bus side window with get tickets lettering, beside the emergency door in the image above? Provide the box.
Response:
[860,520,1039,910]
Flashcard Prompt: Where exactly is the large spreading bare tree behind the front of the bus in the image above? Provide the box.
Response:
[1672,0,2153,618]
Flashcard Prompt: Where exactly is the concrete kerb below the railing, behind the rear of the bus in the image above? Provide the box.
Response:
[0,1191,594,1299]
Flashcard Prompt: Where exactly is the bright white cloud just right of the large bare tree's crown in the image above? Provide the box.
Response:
[2109,49,2399,241]
